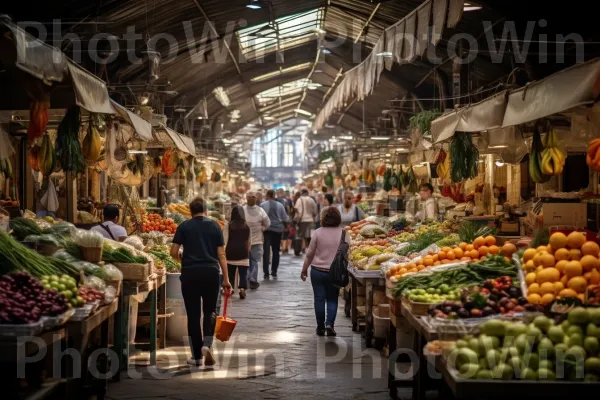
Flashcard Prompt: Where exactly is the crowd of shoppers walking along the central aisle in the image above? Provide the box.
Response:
[169,189,356,366]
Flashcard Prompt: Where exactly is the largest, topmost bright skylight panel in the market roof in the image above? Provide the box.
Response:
[237,8,324,59]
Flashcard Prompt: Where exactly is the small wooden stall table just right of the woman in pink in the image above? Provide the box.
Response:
[348,266,385,347]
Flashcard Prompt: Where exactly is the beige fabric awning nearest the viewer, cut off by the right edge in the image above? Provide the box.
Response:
[503,58,600,126]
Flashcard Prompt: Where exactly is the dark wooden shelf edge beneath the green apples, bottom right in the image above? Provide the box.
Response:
[435,356,600,399]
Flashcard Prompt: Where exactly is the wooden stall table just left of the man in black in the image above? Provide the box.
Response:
[115,274,167,379]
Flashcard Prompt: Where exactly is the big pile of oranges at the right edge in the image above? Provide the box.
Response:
[523,232,600,304]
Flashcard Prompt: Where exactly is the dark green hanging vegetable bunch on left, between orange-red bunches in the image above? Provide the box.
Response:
[56,106,85,174]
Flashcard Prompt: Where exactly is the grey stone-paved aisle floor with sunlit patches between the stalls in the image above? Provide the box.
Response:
[108,256,398,400]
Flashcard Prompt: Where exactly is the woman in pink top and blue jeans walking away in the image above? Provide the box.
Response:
[300,207,350,336]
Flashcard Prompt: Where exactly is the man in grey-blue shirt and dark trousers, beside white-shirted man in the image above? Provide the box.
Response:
[260,190,288,279]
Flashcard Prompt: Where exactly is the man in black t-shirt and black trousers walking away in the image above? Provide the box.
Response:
[171,198,231,366]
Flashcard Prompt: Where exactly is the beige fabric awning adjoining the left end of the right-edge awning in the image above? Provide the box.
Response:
[430,90,507,143]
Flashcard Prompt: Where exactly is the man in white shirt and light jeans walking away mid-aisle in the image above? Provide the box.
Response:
[244,192,271,289]
